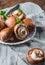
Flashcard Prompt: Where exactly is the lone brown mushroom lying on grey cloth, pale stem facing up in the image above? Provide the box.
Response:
[26,48,44,64]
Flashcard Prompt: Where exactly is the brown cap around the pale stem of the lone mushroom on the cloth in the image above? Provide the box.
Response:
[26,48,44,64]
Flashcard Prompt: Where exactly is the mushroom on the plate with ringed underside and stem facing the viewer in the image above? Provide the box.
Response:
[14,23,29,40]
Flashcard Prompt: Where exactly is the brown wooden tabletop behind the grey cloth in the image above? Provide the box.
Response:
[0,0,45,10]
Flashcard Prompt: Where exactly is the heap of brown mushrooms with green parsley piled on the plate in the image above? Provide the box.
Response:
[0,9,35,41]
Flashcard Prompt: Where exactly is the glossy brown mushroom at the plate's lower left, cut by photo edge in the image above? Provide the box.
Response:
[0,28,12,41]
